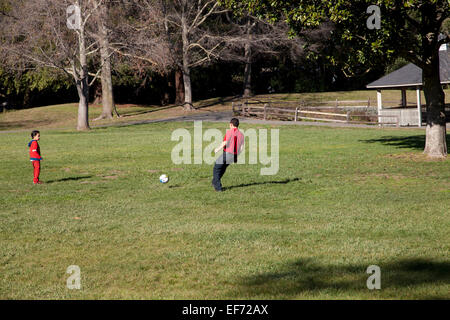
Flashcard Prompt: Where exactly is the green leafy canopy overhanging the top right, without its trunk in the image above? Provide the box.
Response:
[223,0,450,74]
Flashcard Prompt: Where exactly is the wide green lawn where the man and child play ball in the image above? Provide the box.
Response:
[0,123,450,299]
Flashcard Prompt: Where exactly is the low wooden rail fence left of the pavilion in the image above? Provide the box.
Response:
[232,101,399,127]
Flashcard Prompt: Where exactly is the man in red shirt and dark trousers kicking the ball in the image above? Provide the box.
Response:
[212,118,244,191]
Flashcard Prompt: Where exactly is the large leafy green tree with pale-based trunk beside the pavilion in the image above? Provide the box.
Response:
[225,0,450,157]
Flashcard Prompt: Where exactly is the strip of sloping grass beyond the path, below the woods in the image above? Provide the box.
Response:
[0,89,450,131]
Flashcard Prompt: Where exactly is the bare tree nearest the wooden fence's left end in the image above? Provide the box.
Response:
[130,0,226,110]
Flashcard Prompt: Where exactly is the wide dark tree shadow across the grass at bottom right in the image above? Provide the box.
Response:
[239,259,450,299]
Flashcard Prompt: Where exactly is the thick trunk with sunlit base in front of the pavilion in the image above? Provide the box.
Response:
[423,58,447,157]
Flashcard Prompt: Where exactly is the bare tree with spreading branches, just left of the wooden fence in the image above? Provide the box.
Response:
[111,0,226,110]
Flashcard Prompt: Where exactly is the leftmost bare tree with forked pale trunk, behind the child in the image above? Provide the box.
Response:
[1,0,102,130]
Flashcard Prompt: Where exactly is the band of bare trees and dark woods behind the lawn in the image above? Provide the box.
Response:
[0,0,389,116]
